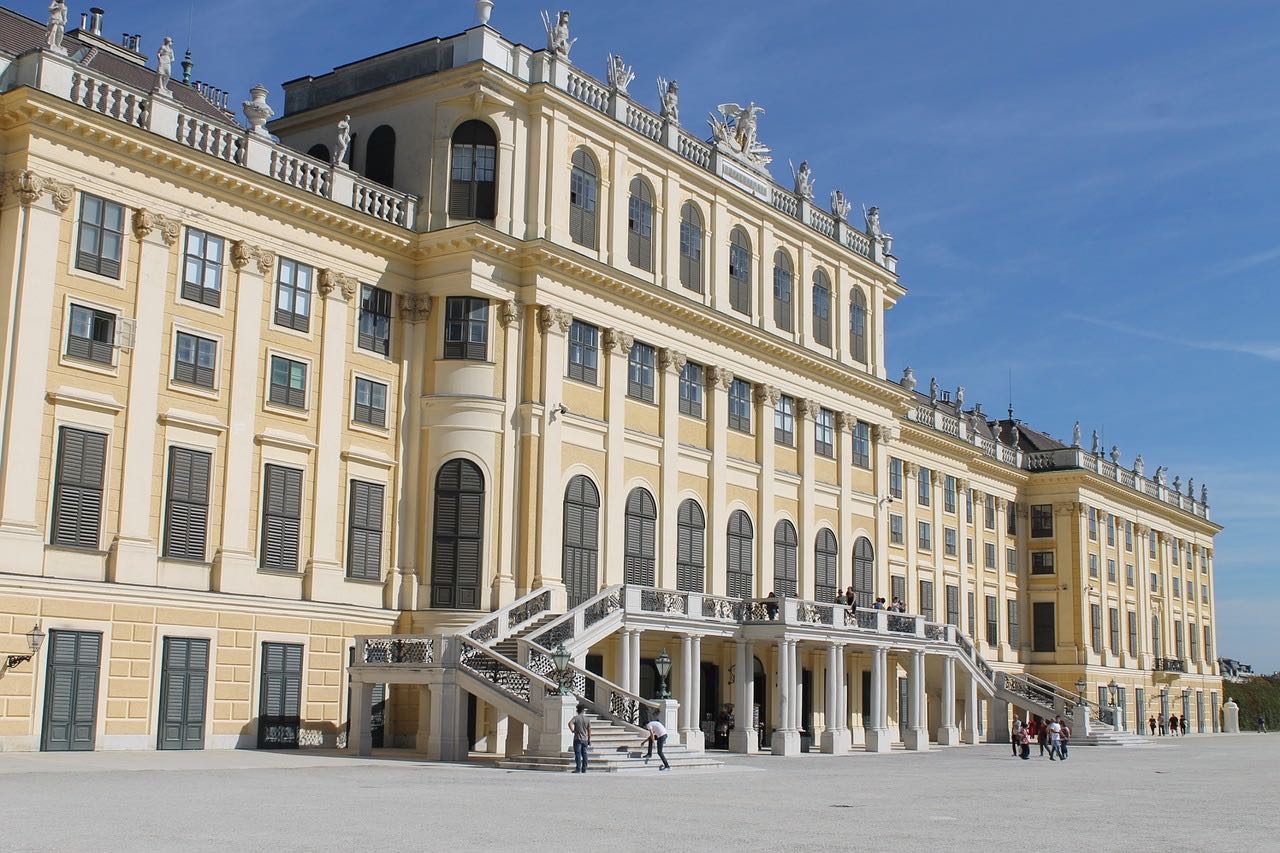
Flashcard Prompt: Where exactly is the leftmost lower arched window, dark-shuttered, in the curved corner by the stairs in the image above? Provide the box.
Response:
[431,459,484,610]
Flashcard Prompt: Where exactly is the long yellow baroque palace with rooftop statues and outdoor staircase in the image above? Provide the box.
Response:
[0,3,1222,766]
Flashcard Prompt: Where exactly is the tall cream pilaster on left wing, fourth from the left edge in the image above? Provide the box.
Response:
[302,269,355,605]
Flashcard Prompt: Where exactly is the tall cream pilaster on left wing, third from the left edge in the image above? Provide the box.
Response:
[212,235,275,594]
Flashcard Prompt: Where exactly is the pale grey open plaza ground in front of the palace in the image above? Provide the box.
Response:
[0,735,1280,852]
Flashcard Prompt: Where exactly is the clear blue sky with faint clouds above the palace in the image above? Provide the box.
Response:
[22,0,1280,671]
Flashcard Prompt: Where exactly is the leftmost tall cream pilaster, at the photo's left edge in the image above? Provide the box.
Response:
[0,170,76,563]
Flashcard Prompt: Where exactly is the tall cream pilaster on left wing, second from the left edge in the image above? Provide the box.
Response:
[108,210,180,585]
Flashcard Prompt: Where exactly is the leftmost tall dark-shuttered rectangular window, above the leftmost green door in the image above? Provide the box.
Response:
[49,427,106,551]
